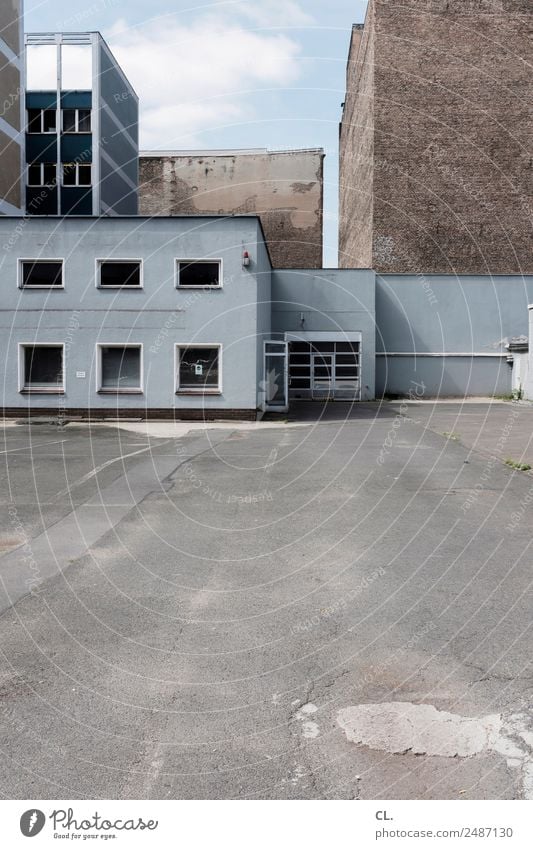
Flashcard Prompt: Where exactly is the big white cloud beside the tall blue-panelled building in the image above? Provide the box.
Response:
[108,10,301,148]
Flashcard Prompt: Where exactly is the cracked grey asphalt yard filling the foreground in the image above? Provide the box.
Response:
[0,402,533,799]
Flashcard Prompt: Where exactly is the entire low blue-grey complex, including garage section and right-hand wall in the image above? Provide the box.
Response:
[0,210,533,419]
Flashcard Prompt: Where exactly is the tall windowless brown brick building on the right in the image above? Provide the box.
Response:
[340,0,533,273]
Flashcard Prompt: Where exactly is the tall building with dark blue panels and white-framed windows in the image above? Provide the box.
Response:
[26,32,139,215]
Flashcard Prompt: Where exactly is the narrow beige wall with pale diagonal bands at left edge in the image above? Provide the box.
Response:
[0,0,24,215]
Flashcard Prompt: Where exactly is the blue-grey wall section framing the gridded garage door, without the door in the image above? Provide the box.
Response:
[272,268,376,401]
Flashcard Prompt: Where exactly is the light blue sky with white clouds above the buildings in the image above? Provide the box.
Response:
[25,0,367,266]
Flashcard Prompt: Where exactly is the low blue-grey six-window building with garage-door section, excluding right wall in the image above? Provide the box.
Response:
[0,216,375,418]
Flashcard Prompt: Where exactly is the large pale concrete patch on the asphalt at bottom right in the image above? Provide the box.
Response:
[337,702,533,799]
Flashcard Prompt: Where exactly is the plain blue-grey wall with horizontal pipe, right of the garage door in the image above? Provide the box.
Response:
[376,274,533,397]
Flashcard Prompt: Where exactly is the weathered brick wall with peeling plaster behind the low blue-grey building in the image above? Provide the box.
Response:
[140,150,324,268]
